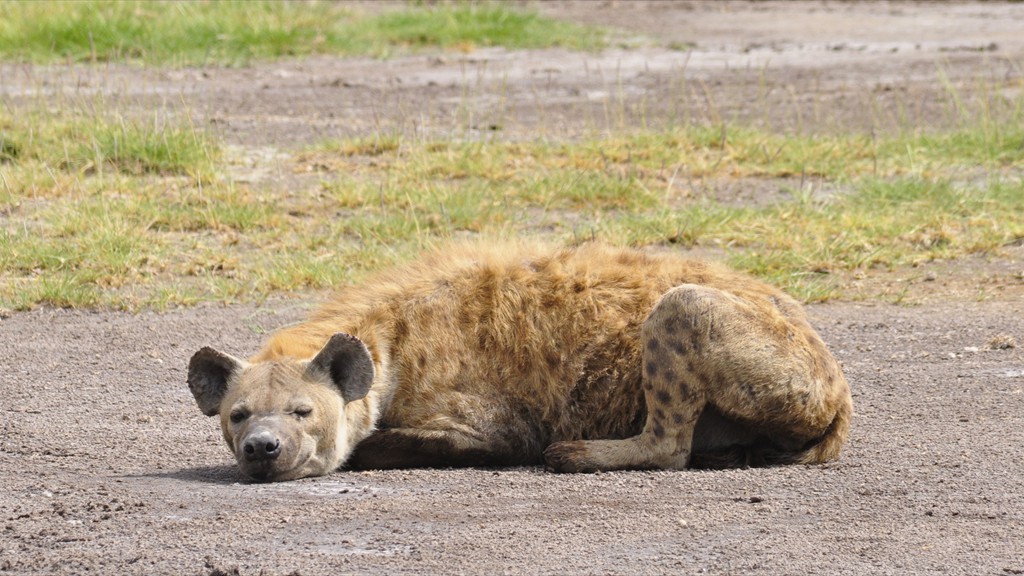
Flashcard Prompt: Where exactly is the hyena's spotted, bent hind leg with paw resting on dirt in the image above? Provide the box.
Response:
[545,285,850,471]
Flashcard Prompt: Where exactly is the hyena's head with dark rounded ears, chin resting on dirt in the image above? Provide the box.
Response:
[188,334,374,482]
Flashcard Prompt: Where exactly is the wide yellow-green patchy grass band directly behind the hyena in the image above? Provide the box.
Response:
[0,100,1024,310]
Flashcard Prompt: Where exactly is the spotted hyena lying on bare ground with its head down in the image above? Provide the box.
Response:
[188,244,851,481]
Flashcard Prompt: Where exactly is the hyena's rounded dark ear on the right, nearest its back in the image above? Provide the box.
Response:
[306,332,374,402]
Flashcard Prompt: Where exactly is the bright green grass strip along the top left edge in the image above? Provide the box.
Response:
[0,0,605,66]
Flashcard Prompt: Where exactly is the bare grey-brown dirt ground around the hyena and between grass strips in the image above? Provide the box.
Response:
[0,0,1024,575]
